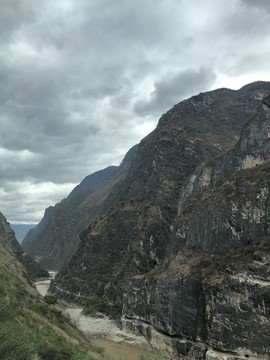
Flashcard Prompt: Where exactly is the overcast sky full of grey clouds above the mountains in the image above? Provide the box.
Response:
[0,0,270,223]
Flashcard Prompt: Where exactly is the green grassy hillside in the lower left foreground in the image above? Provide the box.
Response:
[0,214,114,360]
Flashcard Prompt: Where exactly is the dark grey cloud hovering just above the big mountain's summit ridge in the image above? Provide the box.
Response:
[135,68,216,115]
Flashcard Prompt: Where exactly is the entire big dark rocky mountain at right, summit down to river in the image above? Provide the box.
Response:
[50,82,270,359]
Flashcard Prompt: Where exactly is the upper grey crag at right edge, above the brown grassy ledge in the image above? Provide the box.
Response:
[175,95,270,253]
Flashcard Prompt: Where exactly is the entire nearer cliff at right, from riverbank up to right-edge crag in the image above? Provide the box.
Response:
[123,95,270,359]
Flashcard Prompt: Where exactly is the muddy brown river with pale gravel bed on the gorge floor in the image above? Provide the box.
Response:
[35,272,150,360]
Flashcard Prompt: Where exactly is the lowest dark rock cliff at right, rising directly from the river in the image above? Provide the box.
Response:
[122,239,270,360]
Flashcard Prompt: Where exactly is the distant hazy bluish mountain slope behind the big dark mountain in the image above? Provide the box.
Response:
[22,146,137,270]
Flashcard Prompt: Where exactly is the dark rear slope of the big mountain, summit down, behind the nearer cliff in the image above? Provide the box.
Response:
[52,82,270,302]
